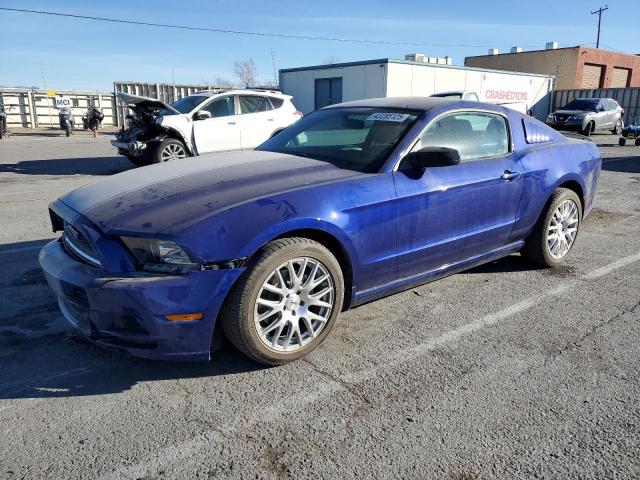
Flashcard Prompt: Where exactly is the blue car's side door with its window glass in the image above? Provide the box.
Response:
[394,111,523,278]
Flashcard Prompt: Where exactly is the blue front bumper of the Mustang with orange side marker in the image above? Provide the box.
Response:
[39,240,243,361]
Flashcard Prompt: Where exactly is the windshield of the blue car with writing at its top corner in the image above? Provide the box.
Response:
[257,107,420,173]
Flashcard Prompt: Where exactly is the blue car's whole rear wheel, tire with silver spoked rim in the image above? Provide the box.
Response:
[522,188,582,267]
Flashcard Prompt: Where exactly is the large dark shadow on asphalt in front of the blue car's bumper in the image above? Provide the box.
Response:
[0,239,265,399]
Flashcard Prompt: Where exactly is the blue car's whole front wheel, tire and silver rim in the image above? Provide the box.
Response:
[220,237,344,366]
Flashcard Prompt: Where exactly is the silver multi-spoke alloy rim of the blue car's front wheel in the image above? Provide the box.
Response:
[254,257,335,352]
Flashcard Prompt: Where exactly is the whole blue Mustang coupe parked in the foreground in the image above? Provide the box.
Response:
[40,98,601,365]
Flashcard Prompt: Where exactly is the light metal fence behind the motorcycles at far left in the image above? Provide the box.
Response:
[0,88,116,128]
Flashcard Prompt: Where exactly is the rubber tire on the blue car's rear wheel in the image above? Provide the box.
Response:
[522,188,582,267]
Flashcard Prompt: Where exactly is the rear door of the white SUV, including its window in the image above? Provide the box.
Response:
[238,95,278,150]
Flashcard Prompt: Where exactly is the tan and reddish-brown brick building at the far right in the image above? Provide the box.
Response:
[464,42,640,90]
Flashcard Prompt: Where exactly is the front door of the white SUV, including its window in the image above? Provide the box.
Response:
[193,95,241,155]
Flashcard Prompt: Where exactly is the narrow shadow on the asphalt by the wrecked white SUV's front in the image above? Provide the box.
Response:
[0,157,135,175]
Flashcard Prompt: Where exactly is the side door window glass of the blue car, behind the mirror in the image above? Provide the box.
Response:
[415,112,509,162]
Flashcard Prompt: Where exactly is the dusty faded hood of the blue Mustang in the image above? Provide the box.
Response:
[60,150,365,235]
